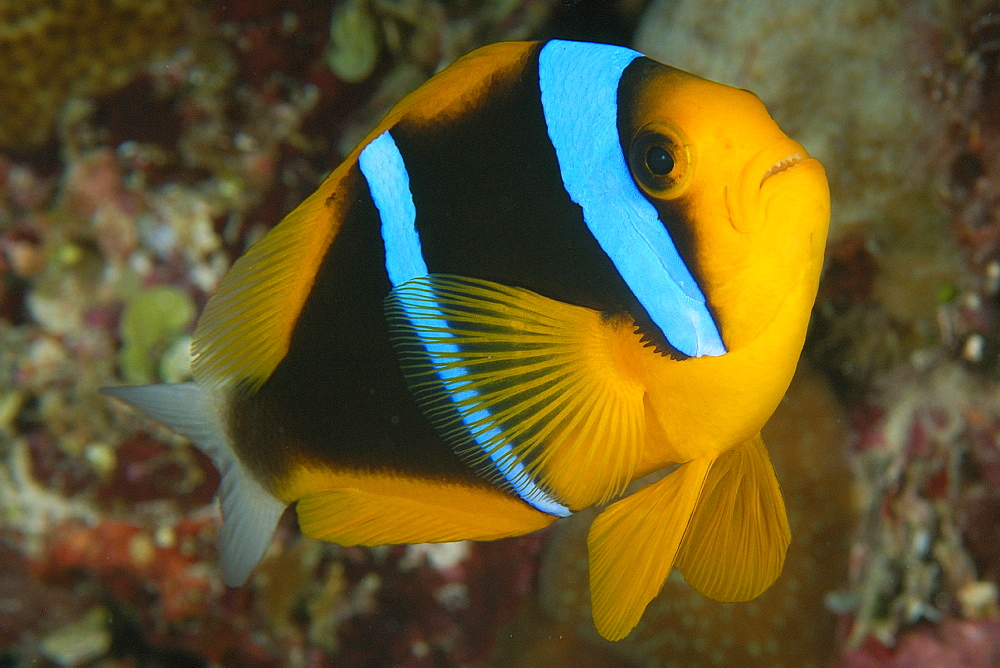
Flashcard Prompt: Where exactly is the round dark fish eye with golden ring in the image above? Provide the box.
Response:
[629,123,691,199]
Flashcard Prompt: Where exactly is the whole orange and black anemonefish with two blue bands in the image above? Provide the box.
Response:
[107,40,829,639]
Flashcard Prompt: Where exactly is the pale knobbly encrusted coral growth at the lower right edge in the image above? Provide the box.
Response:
[844,361,1000,651]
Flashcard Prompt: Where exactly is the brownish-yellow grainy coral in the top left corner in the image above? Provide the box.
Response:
[0,0,194,148]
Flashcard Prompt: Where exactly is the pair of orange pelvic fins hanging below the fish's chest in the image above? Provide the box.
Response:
[587,434,791,640]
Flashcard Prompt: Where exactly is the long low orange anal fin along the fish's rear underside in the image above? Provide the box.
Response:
[296,476,556,546]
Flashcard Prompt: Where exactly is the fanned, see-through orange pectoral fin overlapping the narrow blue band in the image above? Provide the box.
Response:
[386,274,645,514]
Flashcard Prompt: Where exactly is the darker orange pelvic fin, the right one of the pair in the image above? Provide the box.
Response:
[675,434,791,602]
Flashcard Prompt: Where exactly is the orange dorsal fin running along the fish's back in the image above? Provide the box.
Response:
[191,42,533,391]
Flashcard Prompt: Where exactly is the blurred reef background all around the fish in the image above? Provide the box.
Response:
[0,0,1000,668]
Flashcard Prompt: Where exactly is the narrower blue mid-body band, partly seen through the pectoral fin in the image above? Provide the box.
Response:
[358,131,570,517]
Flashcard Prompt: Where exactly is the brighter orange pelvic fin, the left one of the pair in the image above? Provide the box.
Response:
[587,457,713,640]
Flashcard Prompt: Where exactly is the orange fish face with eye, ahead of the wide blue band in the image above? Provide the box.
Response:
[619,63,830,352]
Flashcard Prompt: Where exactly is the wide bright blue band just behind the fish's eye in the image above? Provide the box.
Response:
[538,40,726,357]
